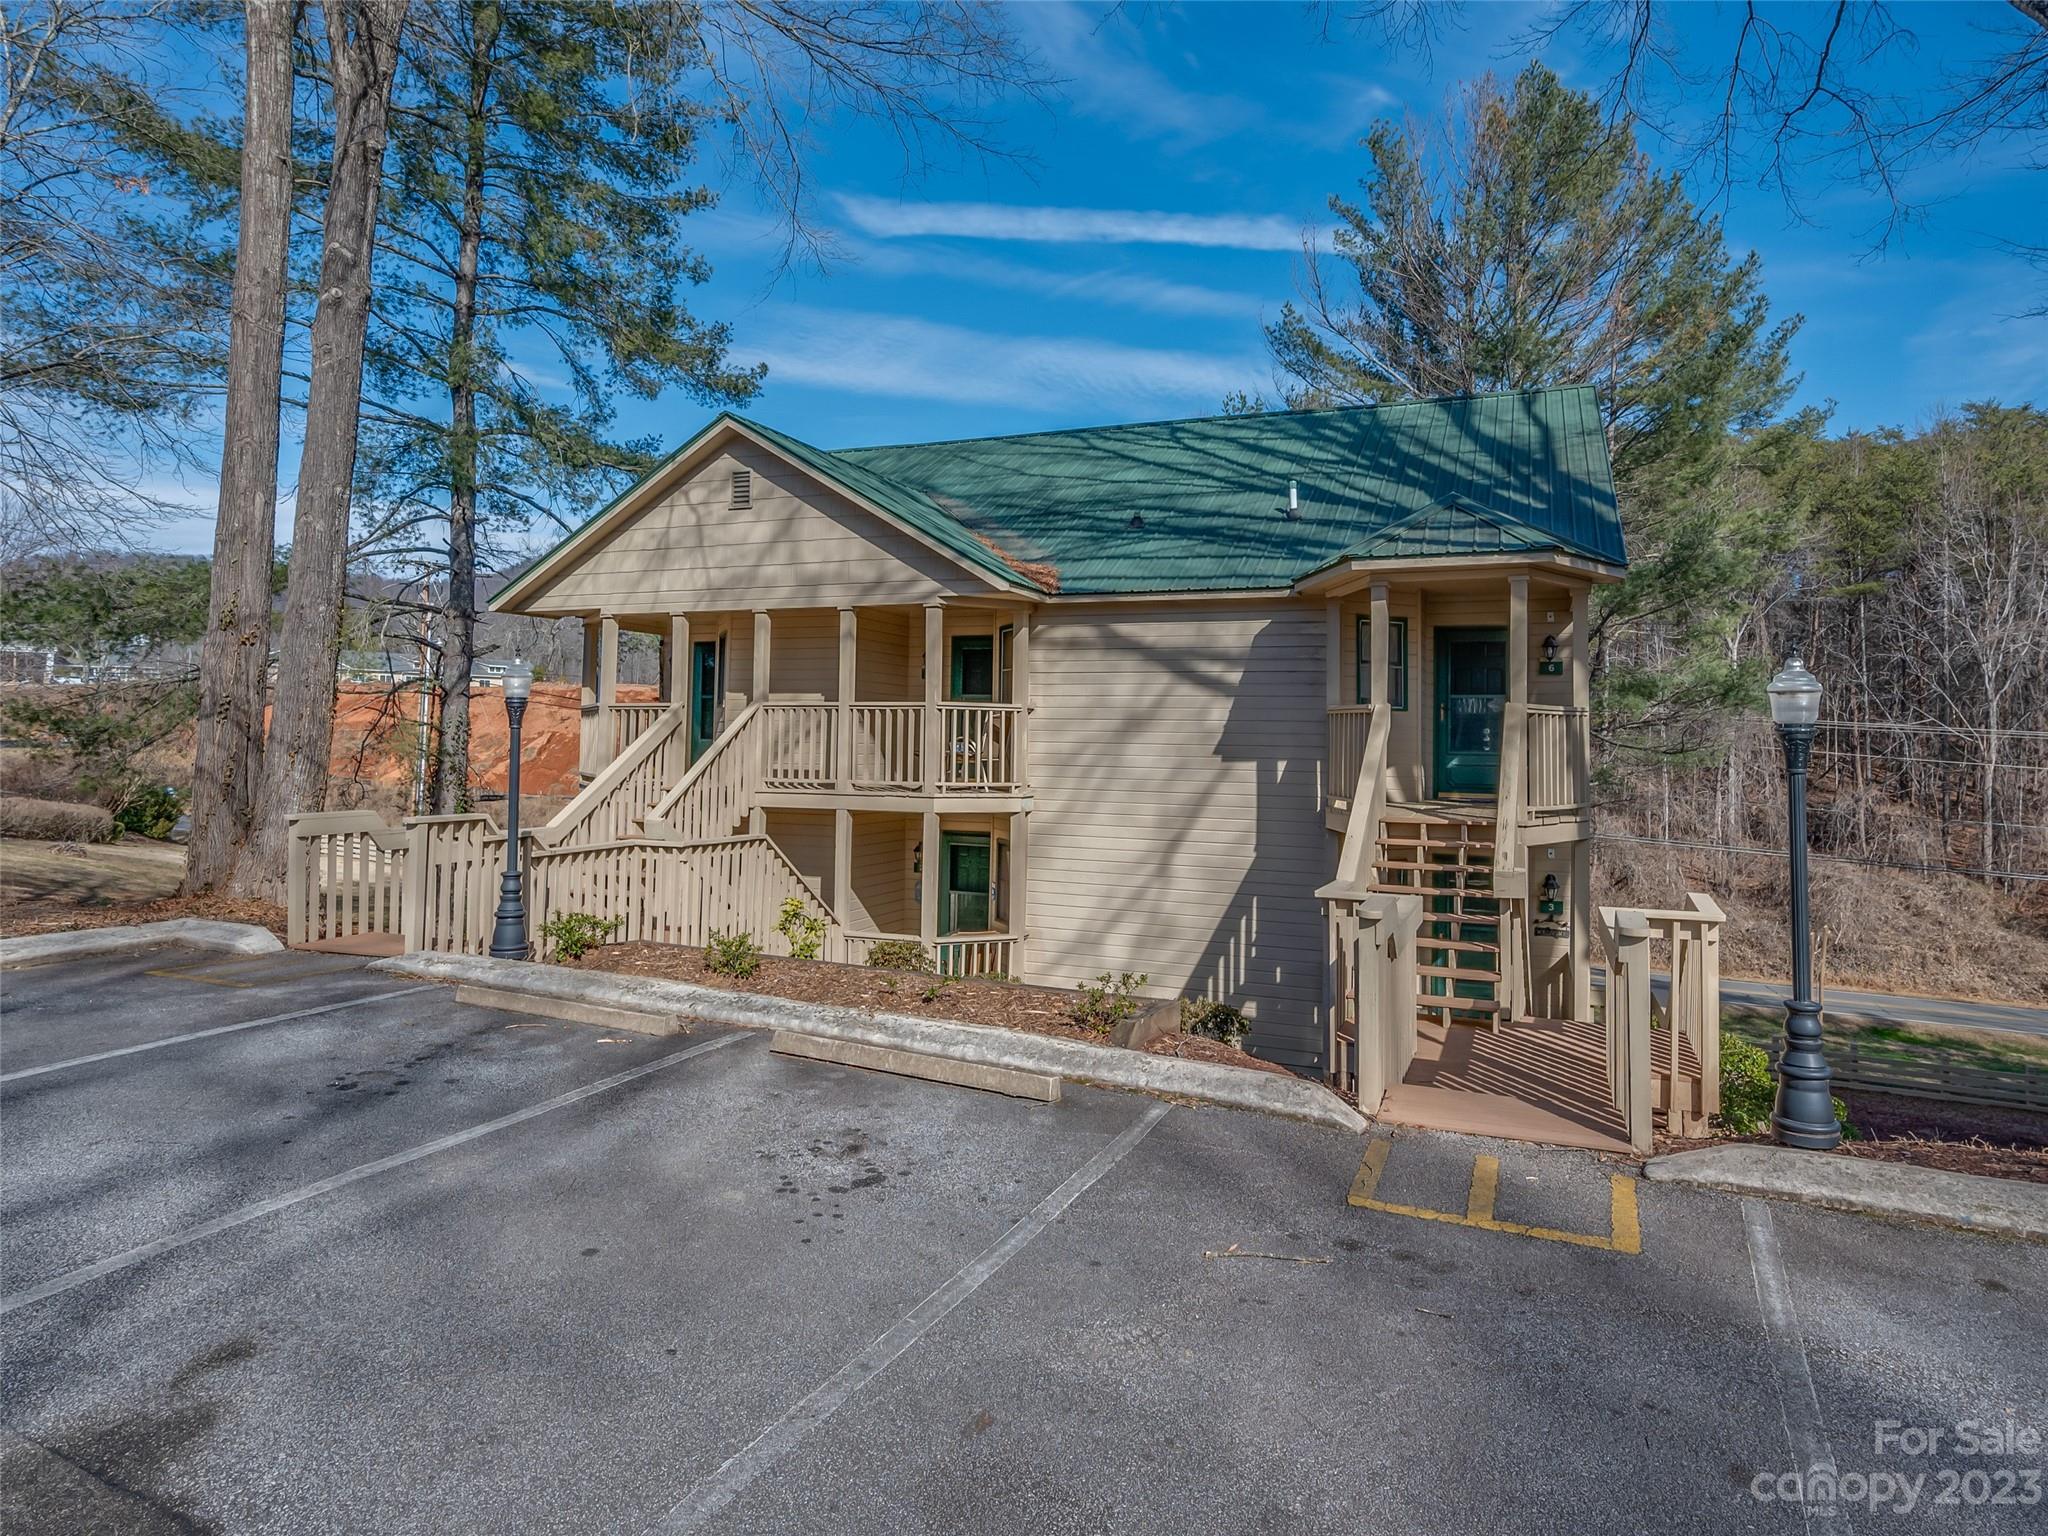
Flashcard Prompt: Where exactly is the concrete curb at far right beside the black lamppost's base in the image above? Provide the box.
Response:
[1642,1145,2048,1243]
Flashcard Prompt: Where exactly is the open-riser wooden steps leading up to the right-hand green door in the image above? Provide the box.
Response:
[1370,819,1509,1028]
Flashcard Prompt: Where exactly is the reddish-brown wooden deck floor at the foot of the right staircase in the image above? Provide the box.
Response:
[1378,1018,1698,1153]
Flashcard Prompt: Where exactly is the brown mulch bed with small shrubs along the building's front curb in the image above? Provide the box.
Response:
[567,942,1286,1073]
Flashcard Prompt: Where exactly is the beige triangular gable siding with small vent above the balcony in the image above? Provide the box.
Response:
[520,442,993,614]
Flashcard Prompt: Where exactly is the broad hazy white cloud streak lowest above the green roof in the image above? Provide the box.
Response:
[756,307,1266,412]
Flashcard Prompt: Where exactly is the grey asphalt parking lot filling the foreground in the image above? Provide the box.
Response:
[0,948,2048,1536]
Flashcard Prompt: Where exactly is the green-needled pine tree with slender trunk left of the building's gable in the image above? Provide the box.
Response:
[360,0,762,813]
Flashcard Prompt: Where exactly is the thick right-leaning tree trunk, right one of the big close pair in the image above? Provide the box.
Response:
[233,0,406,901]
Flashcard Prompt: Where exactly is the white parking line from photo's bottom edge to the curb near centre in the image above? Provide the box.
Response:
[651,1104,1171,1536]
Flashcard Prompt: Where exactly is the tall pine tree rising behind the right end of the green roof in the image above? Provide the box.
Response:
[1268,63,1798,749]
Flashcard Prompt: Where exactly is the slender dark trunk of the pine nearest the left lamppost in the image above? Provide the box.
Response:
[434,6,498,815]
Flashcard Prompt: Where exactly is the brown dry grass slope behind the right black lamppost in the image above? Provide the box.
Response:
[1593,844,2048,1004]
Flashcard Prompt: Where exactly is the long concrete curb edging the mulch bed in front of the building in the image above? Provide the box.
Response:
[371,952,1366,1135]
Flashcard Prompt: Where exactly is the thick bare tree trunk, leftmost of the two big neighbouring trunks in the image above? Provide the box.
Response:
[184,0,293,891]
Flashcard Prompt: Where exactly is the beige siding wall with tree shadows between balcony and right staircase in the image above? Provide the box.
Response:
[1028,602,1335,1067]
